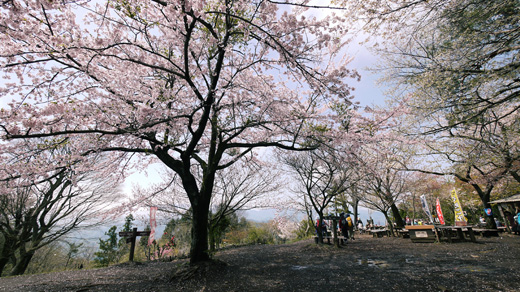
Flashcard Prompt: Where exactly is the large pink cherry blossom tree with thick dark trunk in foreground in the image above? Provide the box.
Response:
[0,0,358,263]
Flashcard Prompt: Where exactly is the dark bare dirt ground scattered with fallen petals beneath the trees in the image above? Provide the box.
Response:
[0,235,520,292]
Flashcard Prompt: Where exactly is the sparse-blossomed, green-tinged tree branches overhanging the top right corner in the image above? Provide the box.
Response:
[340,0,520,133]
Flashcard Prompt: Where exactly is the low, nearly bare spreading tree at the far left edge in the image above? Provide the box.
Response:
[0,152,118,275]
